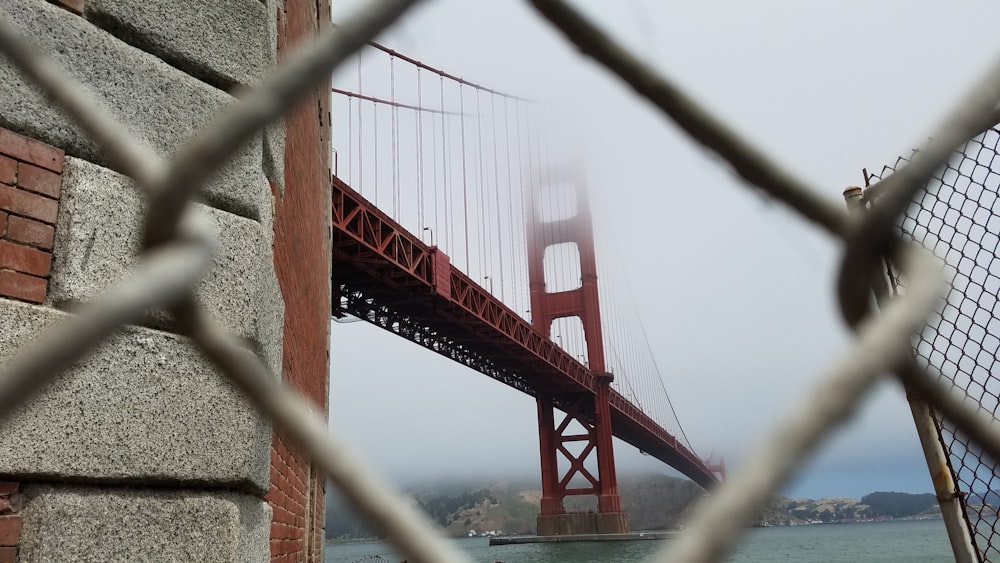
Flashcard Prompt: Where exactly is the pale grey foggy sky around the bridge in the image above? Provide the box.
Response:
[330,0,1000,498]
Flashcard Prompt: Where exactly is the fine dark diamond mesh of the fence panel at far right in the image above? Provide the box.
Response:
[866,128,1000,560]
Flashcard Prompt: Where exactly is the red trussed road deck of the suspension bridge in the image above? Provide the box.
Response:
[331,177,716,488]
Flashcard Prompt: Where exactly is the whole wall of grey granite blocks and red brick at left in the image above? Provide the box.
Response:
[0,0,330,562]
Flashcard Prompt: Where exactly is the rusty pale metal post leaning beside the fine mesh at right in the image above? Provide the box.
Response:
[844,186,982,563]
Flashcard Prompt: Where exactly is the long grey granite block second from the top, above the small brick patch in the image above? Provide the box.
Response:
[0,0,272,228]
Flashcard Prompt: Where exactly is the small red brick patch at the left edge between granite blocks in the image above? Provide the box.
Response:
[0,129,63,303]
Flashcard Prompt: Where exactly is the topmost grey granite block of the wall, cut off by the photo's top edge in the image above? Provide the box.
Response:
[84,0,274,90]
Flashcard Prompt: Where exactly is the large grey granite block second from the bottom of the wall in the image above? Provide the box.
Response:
[0,300,271,494]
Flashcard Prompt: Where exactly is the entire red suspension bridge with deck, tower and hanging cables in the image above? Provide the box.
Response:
[332,44,725,535]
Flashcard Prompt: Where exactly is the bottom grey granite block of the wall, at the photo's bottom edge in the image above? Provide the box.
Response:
[19,486,271,563]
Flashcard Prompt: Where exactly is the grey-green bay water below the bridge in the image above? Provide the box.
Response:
[325,520,953,563]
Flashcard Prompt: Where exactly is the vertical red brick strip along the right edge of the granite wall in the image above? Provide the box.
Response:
[265,0,331,563]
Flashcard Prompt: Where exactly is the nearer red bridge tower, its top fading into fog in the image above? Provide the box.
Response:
[527,174,629,536]
